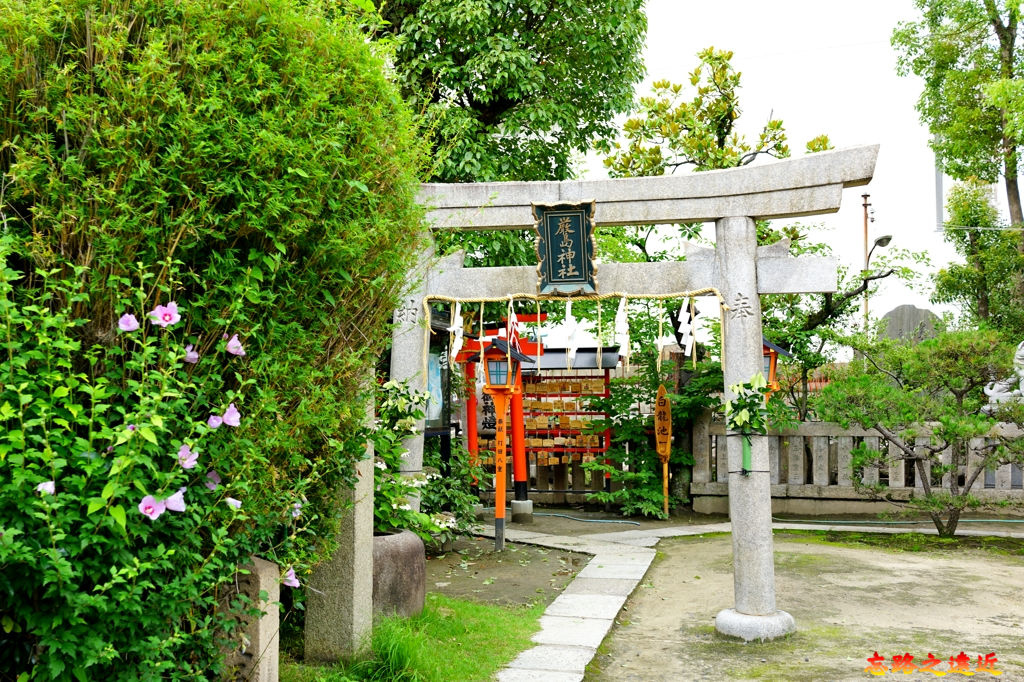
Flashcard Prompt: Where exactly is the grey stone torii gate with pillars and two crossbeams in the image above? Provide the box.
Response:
[391,145,878,640]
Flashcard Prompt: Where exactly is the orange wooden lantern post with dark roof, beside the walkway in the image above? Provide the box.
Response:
[482,338,532,552]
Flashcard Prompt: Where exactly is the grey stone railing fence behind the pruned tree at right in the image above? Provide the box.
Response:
[690,413,1024,514]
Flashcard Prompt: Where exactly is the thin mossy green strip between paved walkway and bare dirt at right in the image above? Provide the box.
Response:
[774,530,1024,556]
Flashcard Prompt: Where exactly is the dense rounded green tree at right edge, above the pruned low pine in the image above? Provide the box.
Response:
[932,175,1024,339]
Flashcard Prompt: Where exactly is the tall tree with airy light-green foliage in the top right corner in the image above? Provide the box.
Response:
[892,0,1024,235]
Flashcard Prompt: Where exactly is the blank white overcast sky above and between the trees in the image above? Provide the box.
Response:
[586,0,970,317]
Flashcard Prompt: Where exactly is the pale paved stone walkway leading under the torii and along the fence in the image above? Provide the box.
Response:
[478,522,1024,682]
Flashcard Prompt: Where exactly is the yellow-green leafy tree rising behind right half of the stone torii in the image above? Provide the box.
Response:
[597,47,919,418]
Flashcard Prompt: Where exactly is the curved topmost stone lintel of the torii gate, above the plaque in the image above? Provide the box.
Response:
[419,144,879,229]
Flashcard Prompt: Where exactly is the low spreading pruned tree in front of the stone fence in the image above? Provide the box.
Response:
[815,331,1024,537]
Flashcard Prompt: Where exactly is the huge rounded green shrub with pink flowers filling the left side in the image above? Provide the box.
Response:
[0,0,422,679]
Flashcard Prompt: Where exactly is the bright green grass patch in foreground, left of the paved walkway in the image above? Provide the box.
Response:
[281,593,545,682]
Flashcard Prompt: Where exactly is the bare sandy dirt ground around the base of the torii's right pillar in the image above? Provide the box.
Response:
[586,534,1024,682]
